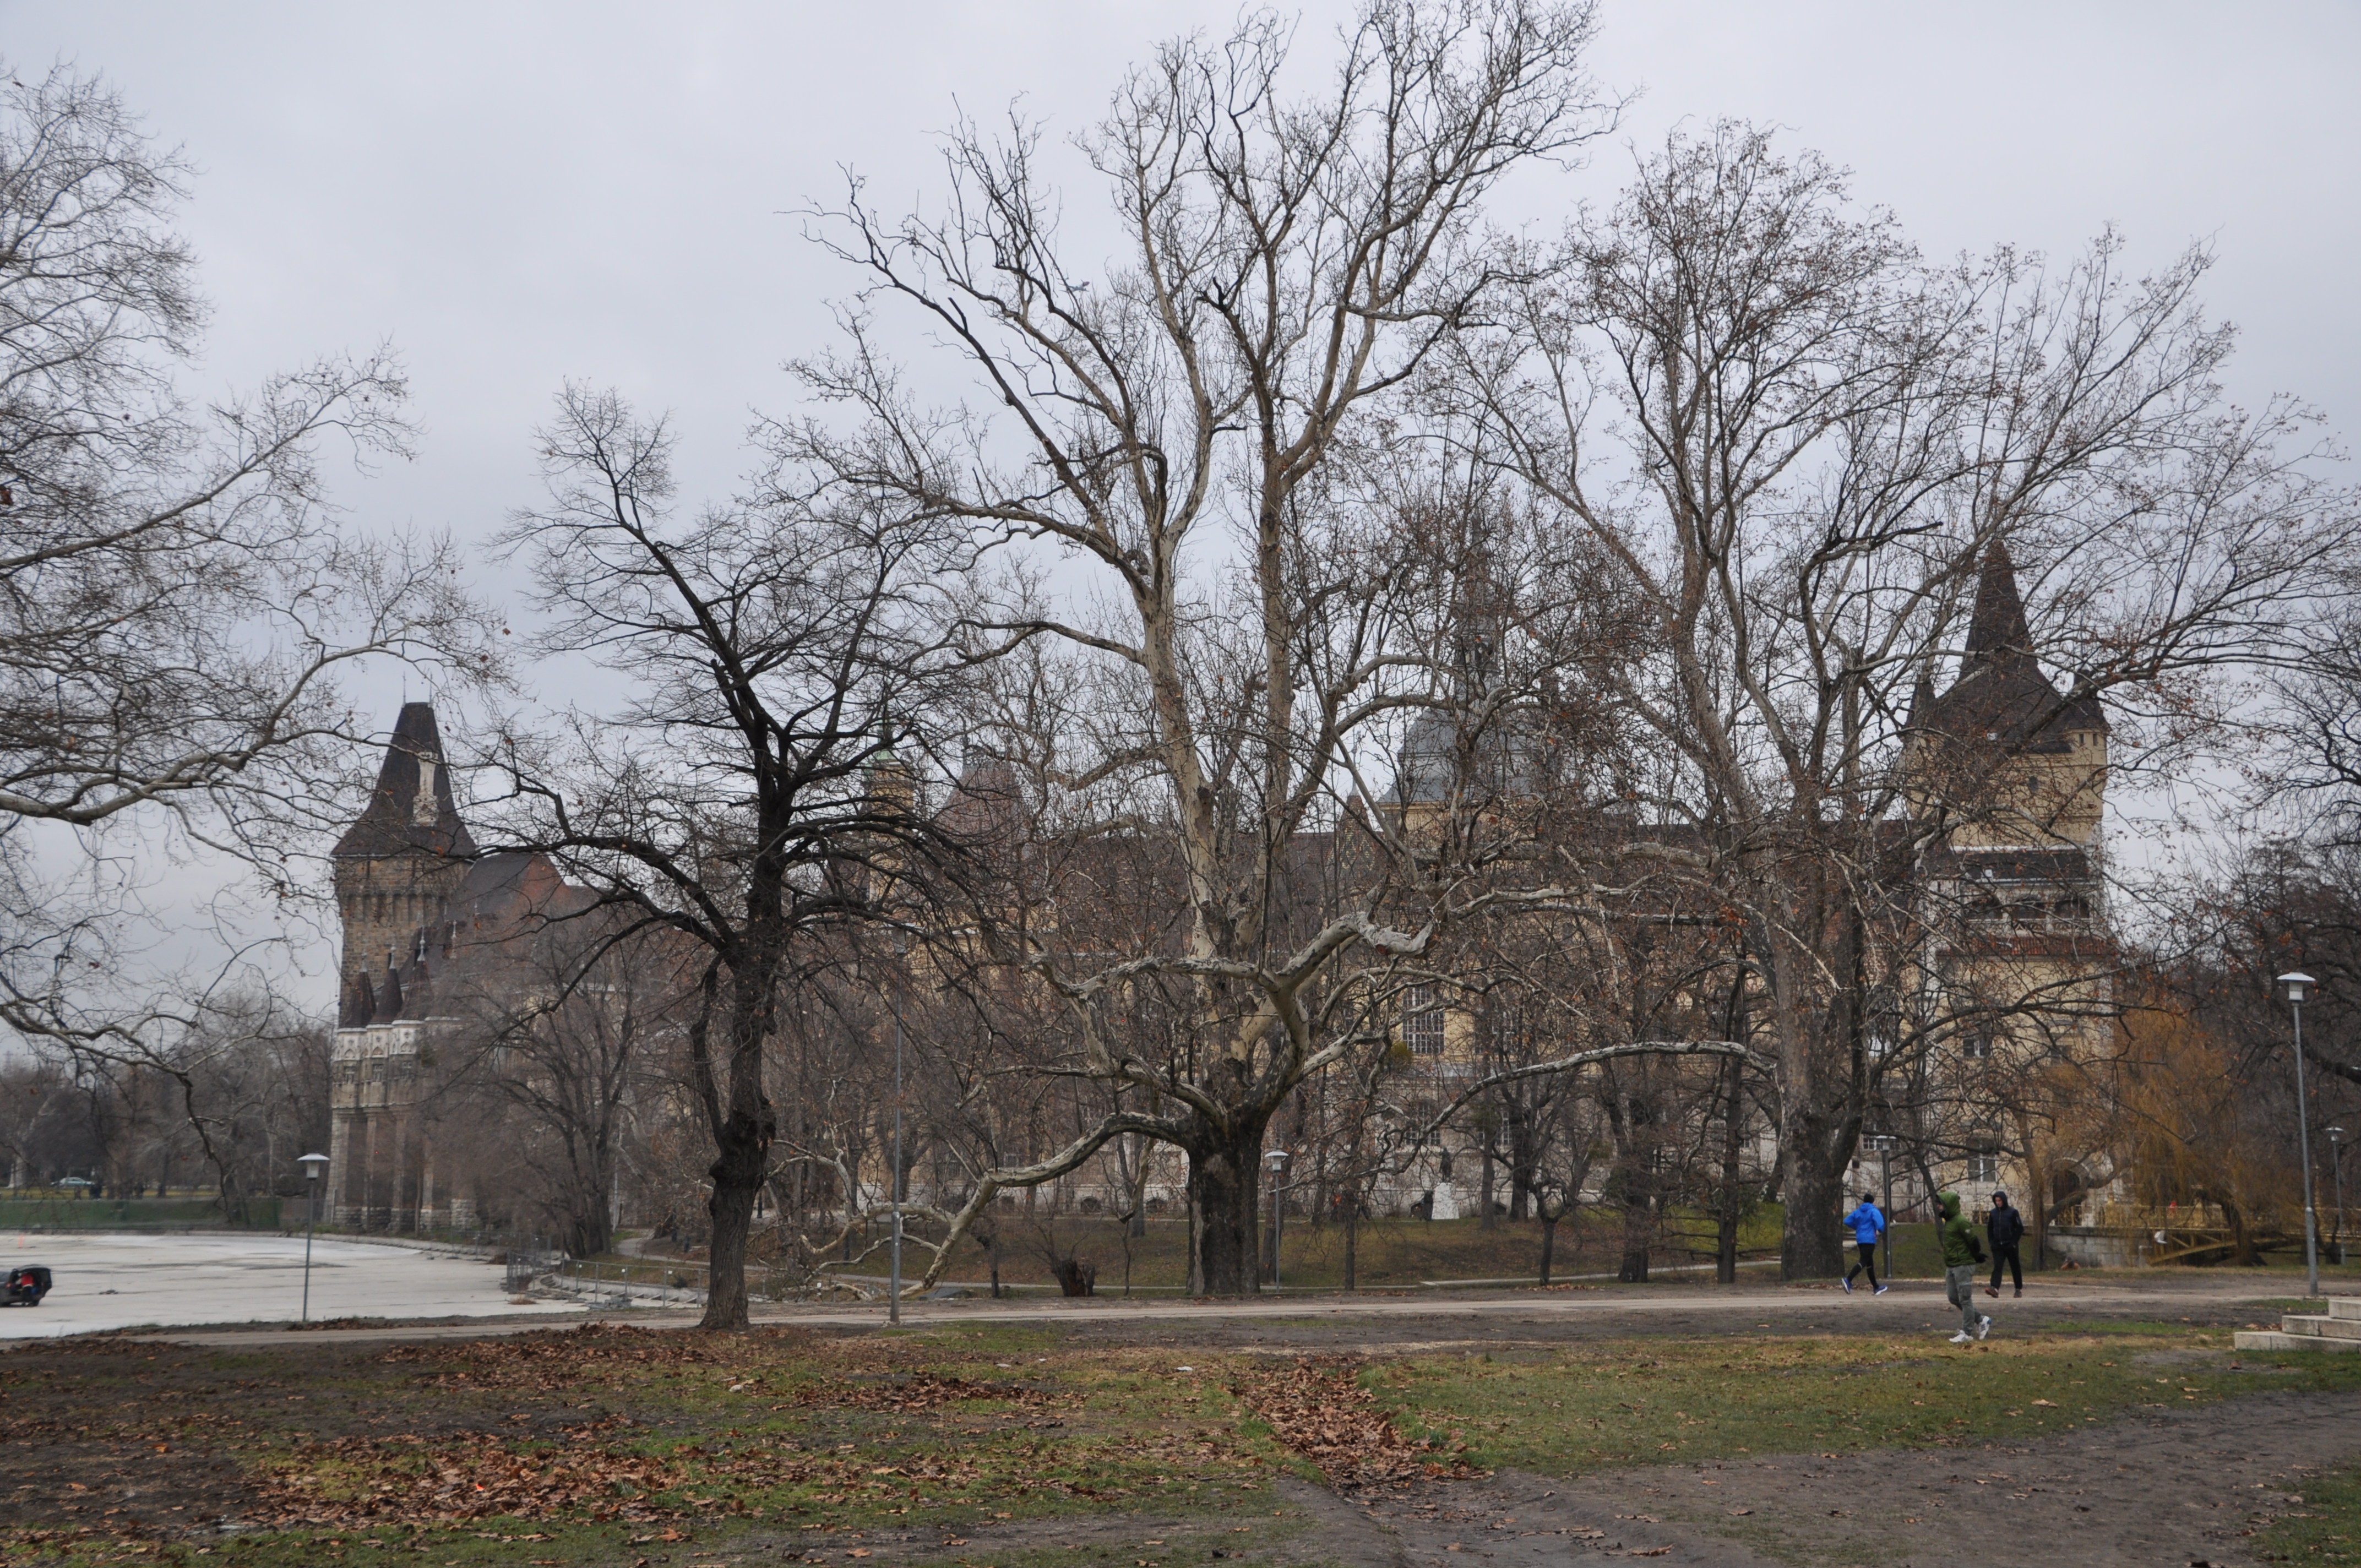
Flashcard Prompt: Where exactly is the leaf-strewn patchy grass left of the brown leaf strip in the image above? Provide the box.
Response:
[0,1325,1294,1568]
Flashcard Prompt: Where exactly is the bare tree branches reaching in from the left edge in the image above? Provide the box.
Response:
[0,66,491,1091]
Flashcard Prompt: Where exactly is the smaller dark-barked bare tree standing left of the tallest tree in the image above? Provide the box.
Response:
[496,387,964,1330]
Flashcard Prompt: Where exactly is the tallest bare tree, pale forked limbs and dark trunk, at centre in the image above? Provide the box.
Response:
[803,0,1613,1294]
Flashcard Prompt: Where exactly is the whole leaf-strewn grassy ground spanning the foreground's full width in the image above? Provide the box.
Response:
[0,1325,2361,1568]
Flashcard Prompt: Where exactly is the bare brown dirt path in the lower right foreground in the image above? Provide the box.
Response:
[1308,1393,2361,1568]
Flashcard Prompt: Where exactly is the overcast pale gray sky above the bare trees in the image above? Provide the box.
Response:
[0,0,2361,992]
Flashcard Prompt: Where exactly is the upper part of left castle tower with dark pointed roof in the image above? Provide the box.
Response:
[333,701,475,997]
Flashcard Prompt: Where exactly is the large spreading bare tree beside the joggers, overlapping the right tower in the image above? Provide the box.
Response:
[1452,125,2356,1275]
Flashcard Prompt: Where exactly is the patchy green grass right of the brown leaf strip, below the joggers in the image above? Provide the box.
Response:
[1362,1325,2361,1476]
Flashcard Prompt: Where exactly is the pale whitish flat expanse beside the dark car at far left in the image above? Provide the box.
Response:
[0,1233,581,1341]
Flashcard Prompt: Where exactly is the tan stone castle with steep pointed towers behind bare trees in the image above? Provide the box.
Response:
[330,548,2115,1231]
